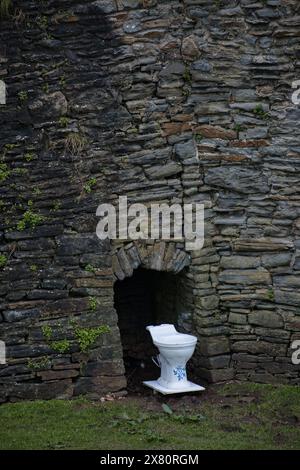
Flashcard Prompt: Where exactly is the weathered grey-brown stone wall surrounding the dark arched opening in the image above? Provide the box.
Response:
[0,0,300,401]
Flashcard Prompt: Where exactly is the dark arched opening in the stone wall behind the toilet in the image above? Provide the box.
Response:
[114,267,188,392]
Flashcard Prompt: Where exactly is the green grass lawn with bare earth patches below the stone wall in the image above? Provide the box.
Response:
[0,384,300,450]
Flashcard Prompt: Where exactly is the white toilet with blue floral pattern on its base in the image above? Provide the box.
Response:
[144,324,205,395]
